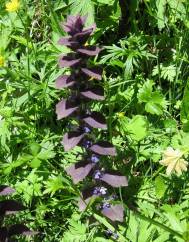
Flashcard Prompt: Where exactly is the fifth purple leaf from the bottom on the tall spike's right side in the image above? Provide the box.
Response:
[81,86,105,100]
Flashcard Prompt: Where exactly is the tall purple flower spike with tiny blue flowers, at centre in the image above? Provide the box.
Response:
[56,16,128,223]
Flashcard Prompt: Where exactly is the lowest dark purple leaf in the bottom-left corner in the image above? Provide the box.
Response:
[8,224,38,237]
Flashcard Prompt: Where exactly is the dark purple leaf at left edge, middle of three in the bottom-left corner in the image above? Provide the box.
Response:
[0,200,25,216]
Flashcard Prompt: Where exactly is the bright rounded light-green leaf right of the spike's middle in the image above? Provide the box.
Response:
[126,115,148,141]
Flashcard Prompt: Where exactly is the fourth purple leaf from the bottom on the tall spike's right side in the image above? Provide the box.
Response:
[83,112,107,129]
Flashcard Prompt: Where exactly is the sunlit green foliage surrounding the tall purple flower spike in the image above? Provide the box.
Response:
[0,0,189,242]
